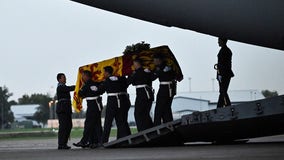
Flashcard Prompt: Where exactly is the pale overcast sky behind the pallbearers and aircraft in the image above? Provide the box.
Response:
[0,0,284,100]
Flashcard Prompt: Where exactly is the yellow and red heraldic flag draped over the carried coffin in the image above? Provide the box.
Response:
[73,46,183,112]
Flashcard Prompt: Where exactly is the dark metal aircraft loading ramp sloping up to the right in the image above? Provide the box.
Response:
[104,95,284,148]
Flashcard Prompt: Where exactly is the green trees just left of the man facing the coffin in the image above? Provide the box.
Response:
[19,94,52,124]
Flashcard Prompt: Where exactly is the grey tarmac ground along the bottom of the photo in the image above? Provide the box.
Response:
[0,135,284,160]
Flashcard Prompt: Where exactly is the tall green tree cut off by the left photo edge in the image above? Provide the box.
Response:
[0,86,14,128]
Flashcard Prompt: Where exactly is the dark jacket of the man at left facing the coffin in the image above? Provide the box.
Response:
[56,83,75,113]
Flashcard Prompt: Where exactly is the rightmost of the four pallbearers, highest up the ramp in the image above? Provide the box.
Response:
[154,54,176,125]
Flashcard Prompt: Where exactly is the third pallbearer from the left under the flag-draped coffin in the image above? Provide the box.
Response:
[127,58,154,131]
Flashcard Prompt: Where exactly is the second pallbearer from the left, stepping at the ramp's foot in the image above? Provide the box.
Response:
[100,66,131,143]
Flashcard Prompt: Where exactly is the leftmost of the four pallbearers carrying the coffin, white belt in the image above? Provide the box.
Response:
[73,70,103,148]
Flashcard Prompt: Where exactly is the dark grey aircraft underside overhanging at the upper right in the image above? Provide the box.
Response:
[72,0,284,50]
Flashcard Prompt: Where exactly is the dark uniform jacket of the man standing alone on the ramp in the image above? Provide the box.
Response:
[217,46,234,77]
